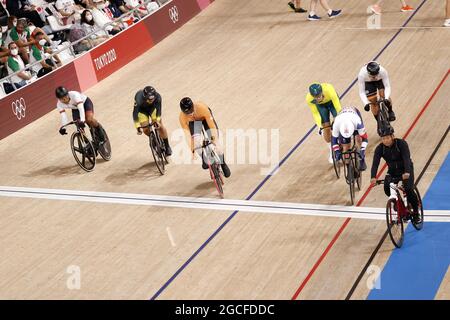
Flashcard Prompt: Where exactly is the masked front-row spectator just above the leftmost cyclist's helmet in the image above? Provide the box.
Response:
[30,32,62,78]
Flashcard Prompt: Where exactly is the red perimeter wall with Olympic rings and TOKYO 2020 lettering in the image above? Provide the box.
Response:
[0,0,214,140]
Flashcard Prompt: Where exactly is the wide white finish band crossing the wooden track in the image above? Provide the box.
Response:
[0,186,450,222]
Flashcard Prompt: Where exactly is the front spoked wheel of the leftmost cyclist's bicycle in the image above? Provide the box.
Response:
[70,132,96,172]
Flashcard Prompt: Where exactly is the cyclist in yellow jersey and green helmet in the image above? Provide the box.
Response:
[306,83,342,163]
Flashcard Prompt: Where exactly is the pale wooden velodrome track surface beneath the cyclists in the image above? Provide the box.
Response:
[0,0,450,299]
